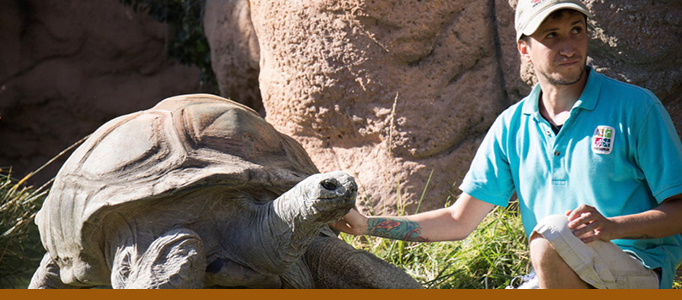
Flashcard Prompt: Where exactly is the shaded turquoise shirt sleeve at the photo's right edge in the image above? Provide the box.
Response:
[636,93,682,203]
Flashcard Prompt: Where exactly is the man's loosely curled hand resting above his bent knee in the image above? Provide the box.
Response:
[566,204,616,243]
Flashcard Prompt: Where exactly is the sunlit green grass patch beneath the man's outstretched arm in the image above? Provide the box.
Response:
[341,202,529,289]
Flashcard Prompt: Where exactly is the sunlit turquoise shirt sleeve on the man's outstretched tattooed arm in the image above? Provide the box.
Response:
[459,116,514,206]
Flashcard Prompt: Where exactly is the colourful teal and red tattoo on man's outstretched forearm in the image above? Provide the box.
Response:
[367,218,429,242]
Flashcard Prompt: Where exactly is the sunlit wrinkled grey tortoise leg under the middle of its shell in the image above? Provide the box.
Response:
[112,228,206,289]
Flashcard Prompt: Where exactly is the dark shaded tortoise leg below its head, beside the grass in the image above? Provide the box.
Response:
[304,236,422,289]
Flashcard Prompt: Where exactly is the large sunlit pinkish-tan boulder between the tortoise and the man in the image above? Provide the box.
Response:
[236,0,510,213]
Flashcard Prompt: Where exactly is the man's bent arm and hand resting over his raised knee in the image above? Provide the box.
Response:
[567,194,682,243]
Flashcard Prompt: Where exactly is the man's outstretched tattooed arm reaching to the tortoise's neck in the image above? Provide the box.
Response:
[330,193,495,242]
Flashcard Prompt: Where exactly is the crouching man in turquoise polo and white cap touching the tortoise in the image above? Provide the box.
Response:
[332,0,682,288]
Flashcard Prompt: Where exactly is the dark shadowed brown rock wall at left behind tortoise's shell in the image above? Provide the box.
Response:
[0,0,209,184]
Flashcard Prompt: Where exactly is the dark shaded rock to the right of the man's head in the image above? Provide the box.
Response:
[586,0,682,131]
